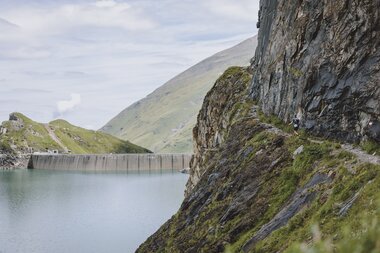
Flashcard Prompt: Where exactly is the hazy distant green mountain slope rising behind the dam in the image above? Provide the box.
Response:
[101,37,256,153]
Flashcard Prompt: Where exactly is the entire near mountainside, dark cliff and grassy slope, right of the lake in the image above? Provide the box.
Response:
[137,0,380,253]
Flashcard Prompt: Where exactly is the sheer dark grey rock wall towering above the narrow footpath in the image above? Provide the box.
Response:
[251,0,380,142]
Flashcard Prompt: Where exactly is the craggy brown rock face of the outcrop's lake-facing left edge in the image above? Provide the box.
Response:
[186,67,252,195]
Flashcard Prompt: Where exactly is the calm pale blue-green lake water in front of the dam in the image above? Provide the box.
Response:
[0,170,188,253]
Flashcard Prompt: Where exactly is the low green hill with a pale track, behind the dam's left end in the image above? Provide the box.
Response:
[0,113,149,154]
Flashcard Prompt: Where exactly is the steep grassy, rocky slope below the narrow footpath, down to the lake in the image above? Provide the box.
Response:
[137,66,380,253]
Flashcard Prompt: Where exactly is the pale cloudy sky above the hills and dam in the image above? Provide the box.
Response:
[0,0,259,129]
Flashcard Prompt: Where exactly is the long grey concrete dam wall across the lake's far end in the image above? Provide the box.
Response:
[28,154,192,172]
